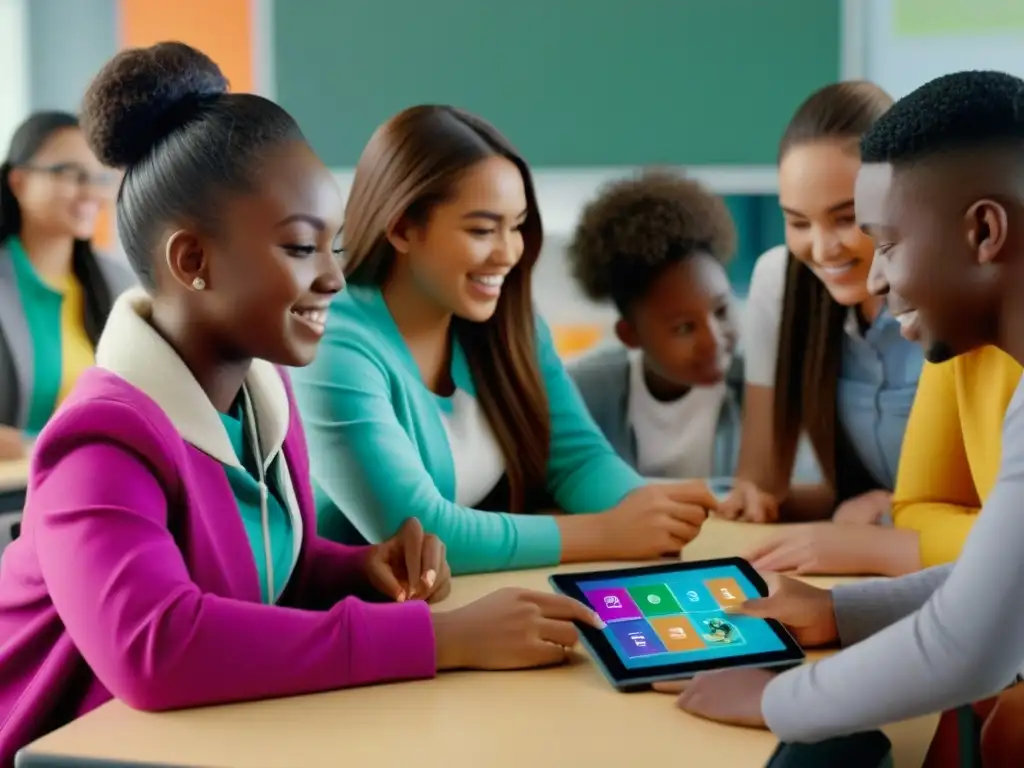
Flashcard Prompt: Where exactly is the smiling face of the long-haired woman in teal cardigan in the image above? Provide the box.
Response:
[388,156,529,323]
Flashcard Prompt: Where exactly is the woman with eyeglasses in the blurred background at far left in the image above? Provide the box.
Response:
[0,112,134,460]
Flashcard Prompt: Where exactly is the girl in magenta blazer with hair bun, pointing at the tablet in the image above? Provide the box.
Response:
[0,43,599,766]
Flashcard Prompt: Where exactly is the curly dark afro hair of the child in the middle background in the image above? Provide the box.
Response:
[568,170,736,315]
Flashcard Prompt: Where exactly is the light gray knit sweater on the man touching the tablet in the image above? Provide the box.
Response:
[762,382,1024,741]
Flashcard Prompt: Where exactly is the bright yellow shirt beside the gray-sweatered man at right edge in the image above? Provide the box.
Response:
[893,347,1024,572]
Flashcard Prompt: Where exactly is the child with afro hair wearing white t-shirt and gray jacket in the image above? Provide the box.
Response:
[569,171,743,479]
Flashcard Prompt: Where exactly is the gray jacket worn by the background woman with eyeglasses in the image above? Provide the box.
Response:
[0,246,136,428]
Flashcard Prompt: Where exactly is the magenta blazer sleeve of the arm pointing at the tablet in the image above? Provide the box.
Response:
[30,400,435,710]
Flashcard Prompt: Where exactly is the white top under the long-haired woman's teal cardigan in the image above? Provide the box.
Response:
[441,389,505,507]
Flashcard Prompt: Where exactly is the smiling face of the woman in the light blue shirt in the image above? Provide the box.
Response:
[778,140,872,306]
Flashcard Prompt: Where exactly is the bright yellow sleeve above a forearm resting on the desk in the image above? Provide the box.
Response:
[893,360,981,567]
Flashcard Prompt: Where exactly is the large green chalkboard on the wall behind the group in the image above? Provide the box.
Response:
[272,0,842,167]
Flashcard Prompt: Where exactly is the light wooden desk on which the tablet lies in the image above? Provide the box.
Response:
[26,520,937,768]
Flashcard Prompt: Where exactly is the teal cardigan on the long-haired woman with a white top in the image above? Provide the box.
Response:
[294,287,644,573]
